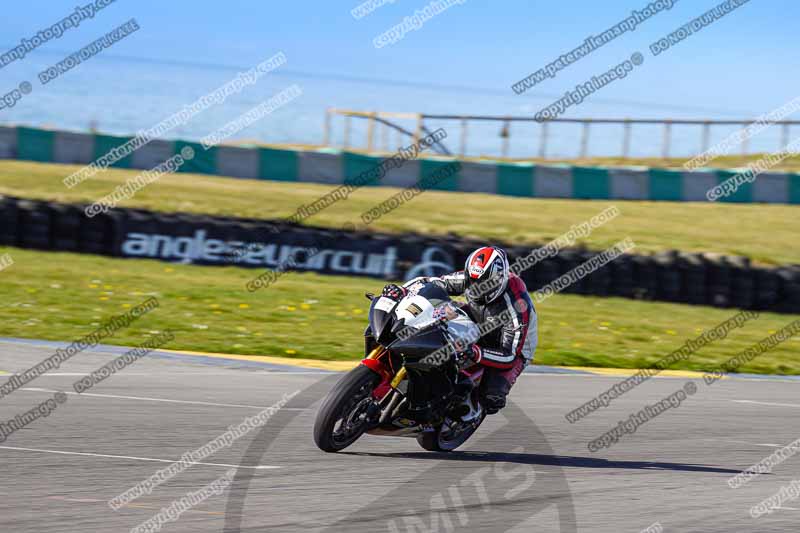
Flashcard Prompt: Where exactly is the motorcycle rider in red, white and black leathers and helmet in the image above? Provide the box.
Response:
[364,246,538,414]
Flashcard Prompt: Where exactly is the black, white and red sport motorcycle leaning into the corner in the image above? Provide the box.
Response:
[314,281,486,452]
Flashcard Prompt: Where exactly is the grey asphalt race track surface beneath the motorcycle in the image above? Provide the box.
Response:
[0,342,800,533]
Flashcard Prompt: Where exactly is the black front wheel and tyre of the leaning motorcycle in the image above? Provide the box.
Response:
[314,365,381,452]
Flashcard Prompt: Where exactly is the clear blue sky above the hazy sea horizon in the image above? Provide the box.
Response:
[0,0,800,156]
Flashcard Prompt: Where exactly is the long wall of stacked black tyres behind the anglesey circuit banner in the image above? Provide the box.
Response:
[0,197,800,313]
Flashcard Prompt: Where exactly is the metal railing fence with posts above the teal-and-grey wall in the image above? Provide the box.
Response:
[324,108,800,159]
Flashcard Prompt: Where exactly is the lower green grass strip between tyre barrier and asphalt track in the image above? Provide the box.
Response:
[0,248,800,374]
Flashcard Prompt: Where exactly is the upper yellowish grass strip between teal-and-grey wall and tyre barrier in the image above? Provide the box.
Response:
[0,161,800,264]
